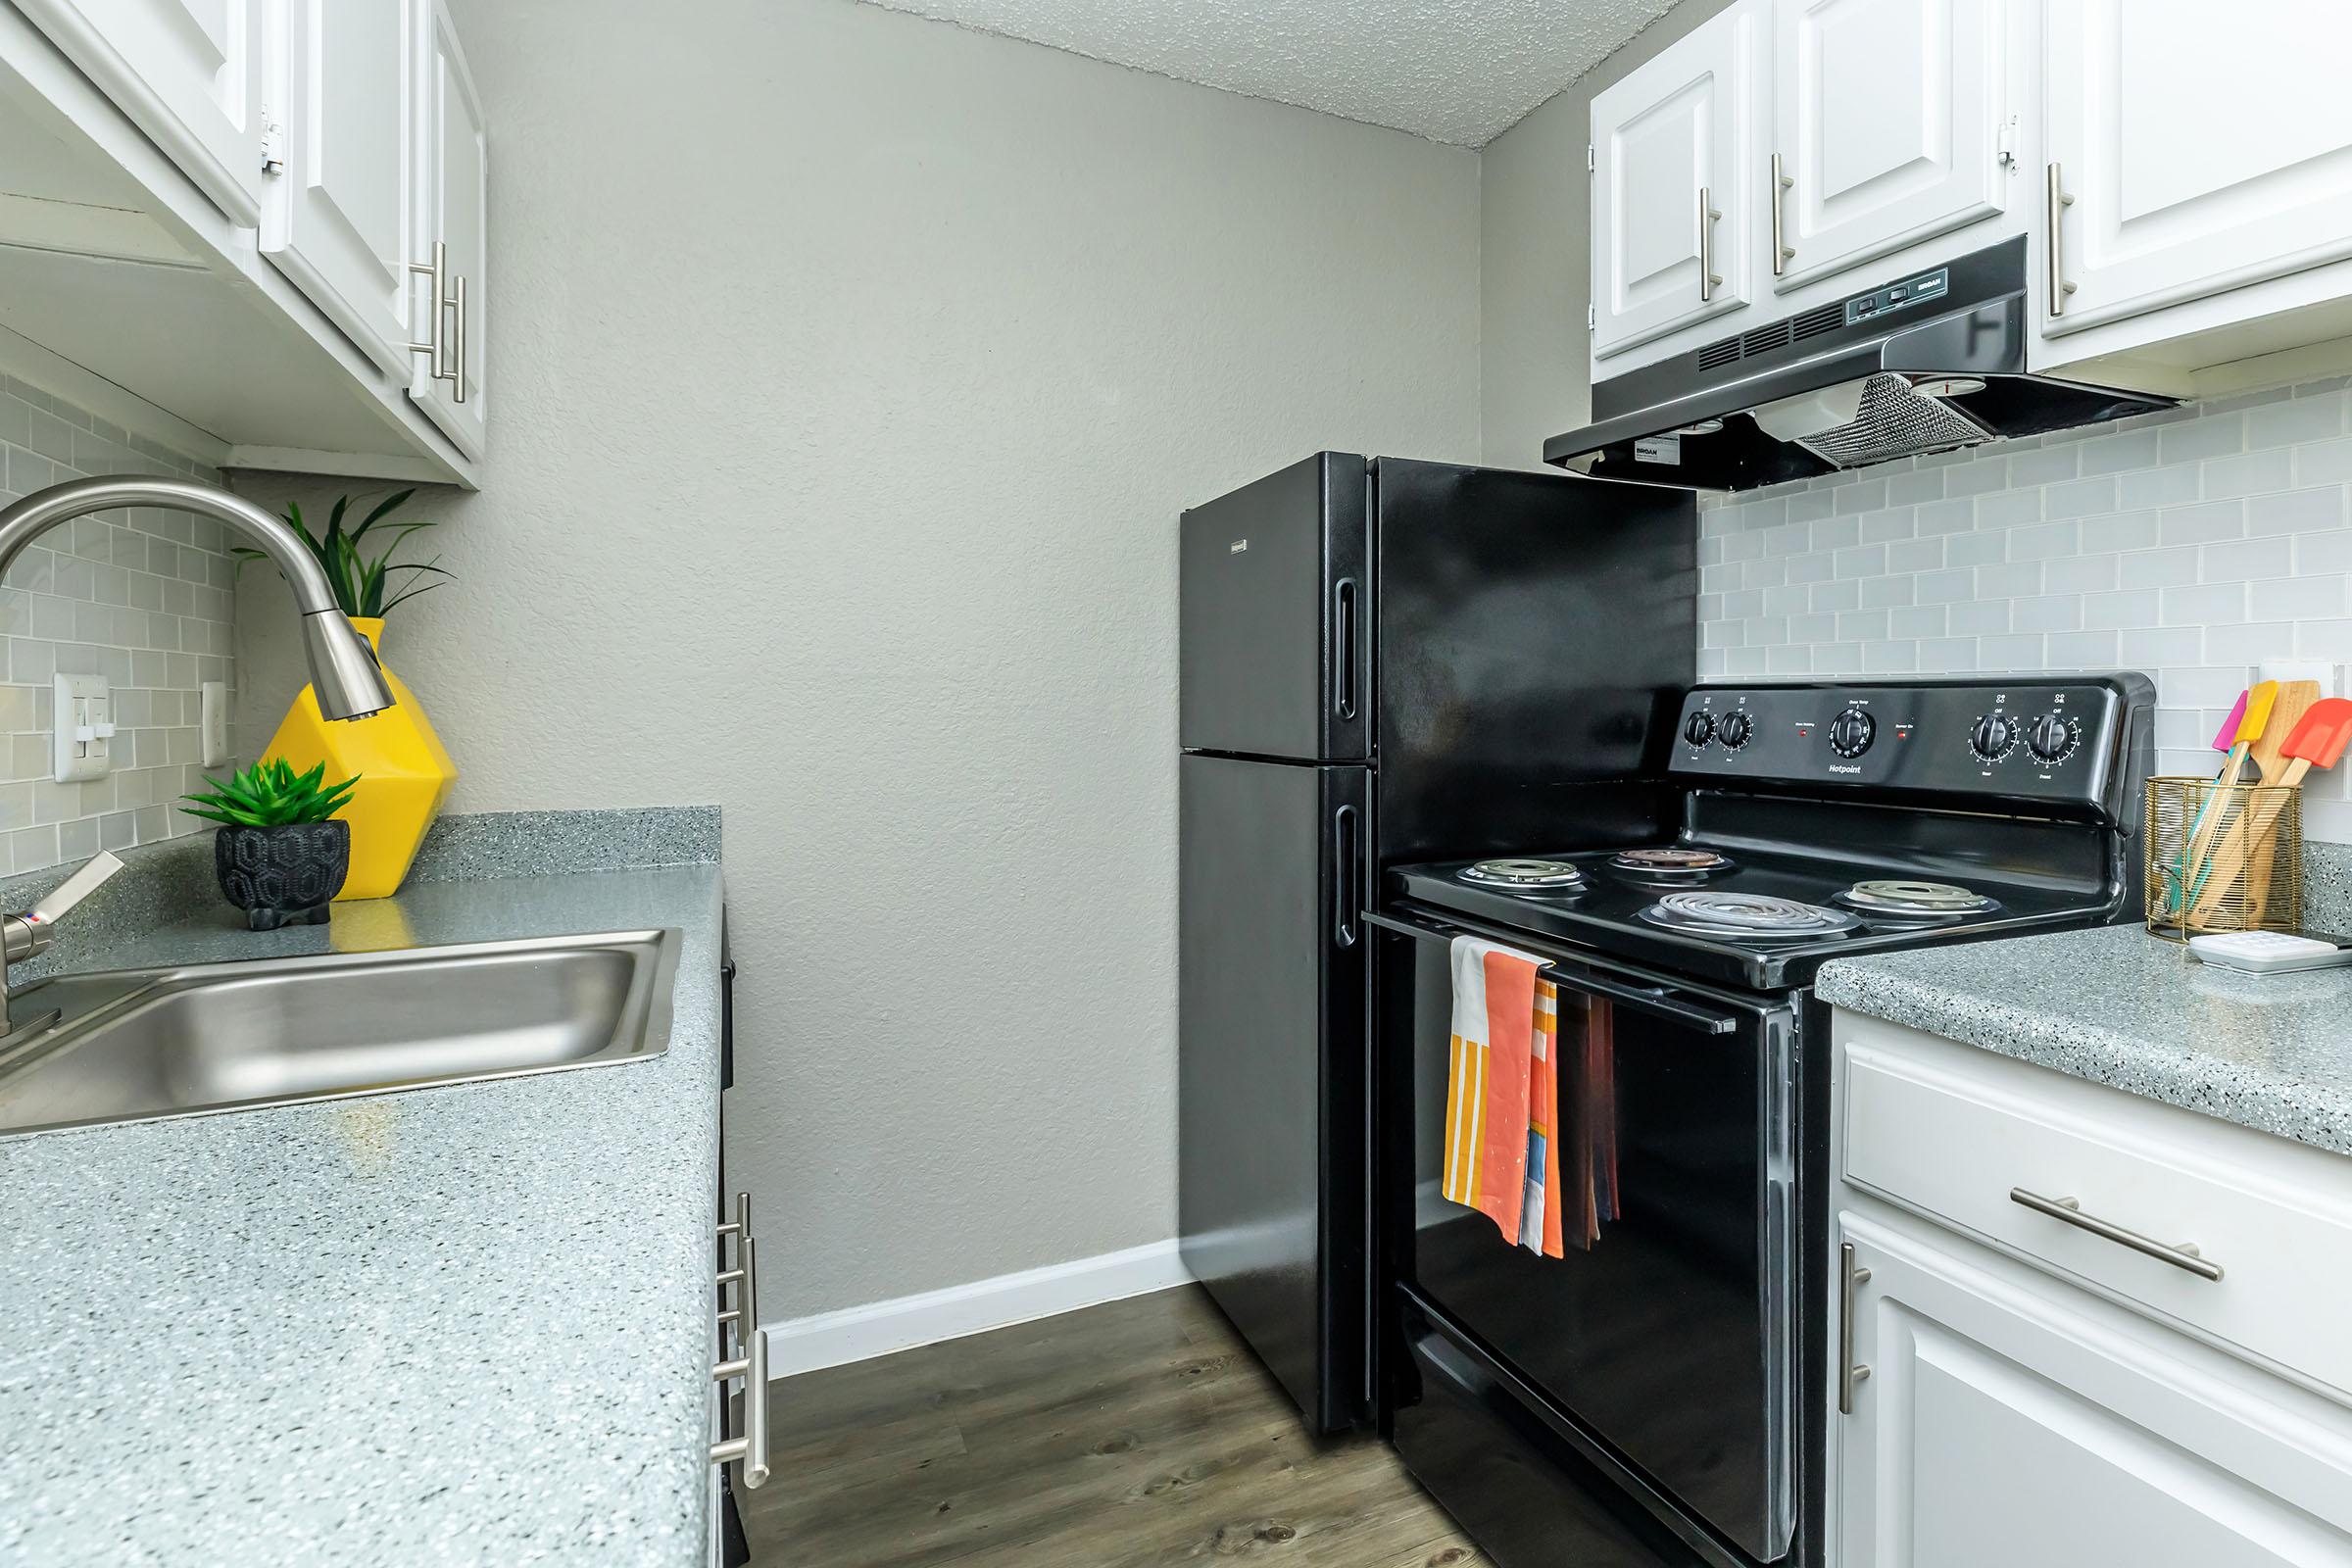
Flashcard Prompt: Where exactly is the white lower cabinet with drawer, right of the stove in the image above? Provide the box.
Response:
[1823,1010,2352,1568]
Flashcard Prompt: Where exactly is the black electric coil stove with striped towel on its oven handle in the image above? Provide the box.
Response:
[1366,674,2154,1568]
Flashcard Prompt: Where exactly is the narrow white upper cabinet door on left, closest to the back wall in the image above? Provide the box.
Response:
[410,0,489,459]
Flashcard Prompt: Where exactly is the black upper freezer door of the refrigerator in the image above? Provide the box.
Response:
[1178,452,1371,761]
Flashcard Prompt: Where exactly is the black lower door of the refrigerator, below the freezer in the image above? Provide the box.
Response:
[1176,757,1371,1432]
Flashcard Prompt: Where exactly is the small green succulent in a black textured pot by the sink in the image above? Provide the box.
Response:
[181,757,360,931]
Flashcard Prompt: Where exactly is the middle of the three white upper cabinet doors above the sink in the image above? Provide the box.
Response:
[261,0,428,381]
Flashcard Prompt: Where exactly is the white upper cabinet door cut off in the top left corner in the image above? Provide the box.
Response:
[17,0,264,228]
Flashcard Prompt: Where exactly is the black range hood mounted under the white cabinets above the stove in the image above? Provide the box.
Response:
[1543,235,2174,489]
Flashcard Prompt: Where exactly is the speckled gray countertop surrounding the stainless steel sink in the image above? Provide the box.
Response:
[0,811,719,1568]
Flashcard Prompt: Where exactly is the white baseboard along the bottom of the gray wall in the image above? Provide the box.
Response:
[764,1242,1193,1378]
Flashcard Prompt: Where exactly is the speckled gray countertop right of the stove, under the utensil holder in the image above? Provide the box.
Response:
[1813,926,2352,1154]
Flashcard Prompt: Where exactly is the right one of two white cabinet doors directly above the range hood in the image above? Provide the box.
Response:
[1764,0,2006,289]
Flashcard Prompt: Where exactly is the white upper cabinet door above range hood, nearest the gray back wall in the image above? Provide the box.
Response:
[1592,0,1762,358]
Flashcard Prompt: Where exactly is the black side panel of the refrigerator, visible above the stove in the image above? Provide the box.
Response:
[1374,459,1698,865]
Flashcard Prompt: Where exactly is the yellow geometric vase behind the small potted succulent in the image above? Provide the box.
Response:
[261,615,457,901]
